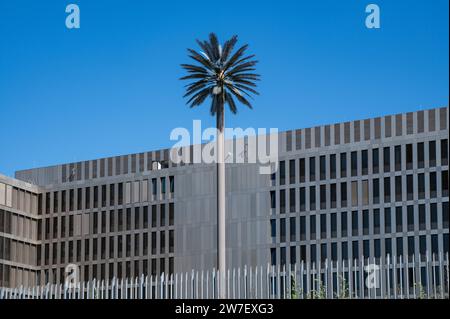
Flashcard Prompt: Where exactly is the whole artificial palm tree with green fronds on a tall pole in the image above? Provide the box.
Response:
[181,33,259,298]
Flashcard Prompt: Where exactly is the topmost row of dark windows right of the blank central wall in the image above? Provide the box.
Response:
[272,139,448,185]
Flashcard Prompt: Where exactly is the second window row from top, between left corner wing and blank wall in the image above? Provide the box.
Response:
[37,203,175,240]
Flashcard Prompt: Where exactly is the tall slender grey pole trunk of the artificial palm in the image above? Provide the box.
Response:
[216,105,226,299]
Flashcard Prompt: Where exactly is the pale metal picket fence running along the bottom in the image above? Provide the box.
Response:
[0,253,449,299]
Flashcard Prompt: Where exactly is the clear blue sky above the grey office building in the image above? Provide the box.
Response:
[0,0,449,176]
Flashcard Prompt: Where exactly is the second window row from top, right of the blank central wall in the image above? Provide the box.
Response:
[270,170,449,214]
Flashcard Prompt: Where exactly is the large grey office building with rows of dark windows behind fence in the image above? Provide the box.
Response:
[0,107,449,286]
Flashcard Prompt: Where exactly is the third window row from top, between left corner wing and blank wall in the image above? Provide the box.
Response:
[37,230,175,266]
